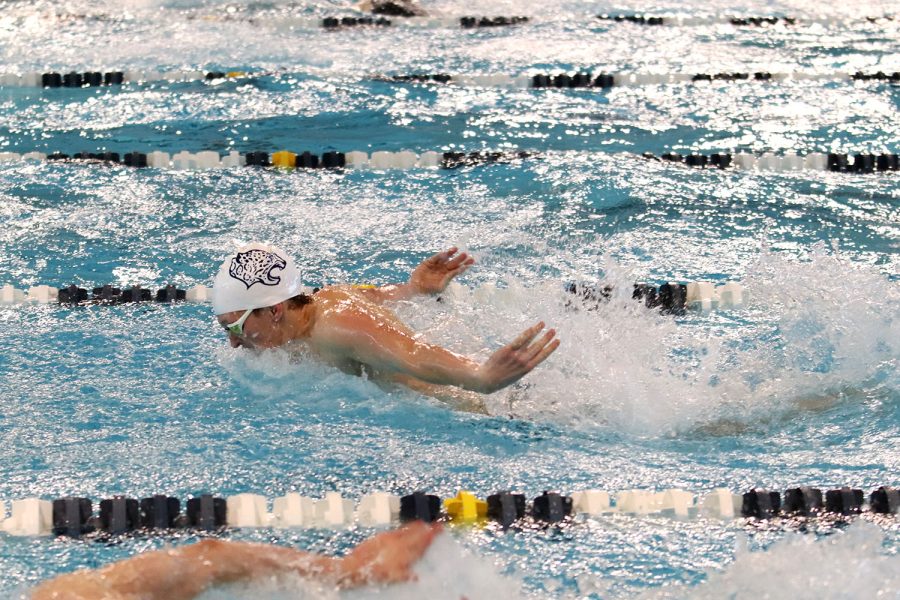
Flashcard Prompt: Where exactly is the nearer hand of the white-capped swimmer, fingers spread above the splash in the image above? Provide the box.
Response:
[477,321,559,394]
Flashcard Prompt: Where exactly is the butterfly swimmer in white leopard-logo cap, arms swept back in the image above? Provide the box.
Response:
[212,243,559,412]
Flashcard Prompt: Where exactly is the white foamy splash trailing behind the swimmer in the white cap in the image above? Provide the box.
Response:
[390,248,900,435]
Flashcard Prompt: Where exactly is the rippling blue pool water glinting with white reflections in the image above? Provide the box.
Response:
[0,1,900,598]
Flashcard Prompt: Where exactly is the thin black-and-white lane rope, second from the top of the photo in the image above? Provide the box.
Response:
[0,69,900,90]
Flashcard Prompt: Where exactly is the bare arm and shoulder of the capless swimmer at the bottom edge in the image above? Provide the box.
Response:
[31,522,440,600]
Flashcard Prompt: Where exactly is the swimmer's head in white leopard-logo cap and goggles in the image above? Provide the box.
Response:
[212,243,303,347]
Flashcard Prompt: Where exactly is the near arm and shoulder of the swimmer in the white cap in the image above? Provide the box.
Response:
[306,286,559,394]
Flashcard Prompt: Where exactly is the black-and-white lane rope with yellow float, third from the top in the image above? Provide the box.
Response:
[0,150,900,174]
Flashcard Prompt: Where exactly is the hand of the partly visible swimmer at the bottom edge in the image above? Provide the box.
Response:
[339,521,441,587]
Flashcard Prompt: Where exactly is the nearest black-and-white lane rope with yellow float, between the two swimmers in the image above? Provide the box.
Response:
[0,487,900,537]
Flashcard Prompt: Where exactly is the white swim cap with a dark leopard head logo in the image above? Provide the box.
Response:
[212,243,303,315]
